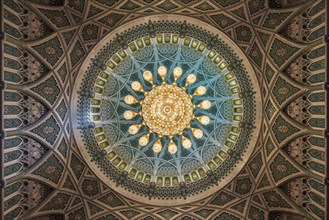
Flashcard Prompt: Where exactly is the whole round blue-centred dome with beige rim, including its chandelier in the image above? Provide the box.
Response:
[71,15,262,205]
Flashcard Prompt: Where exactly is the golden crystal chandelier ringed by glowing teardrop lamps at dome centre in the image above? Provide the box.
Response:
[123,66,211,154]
